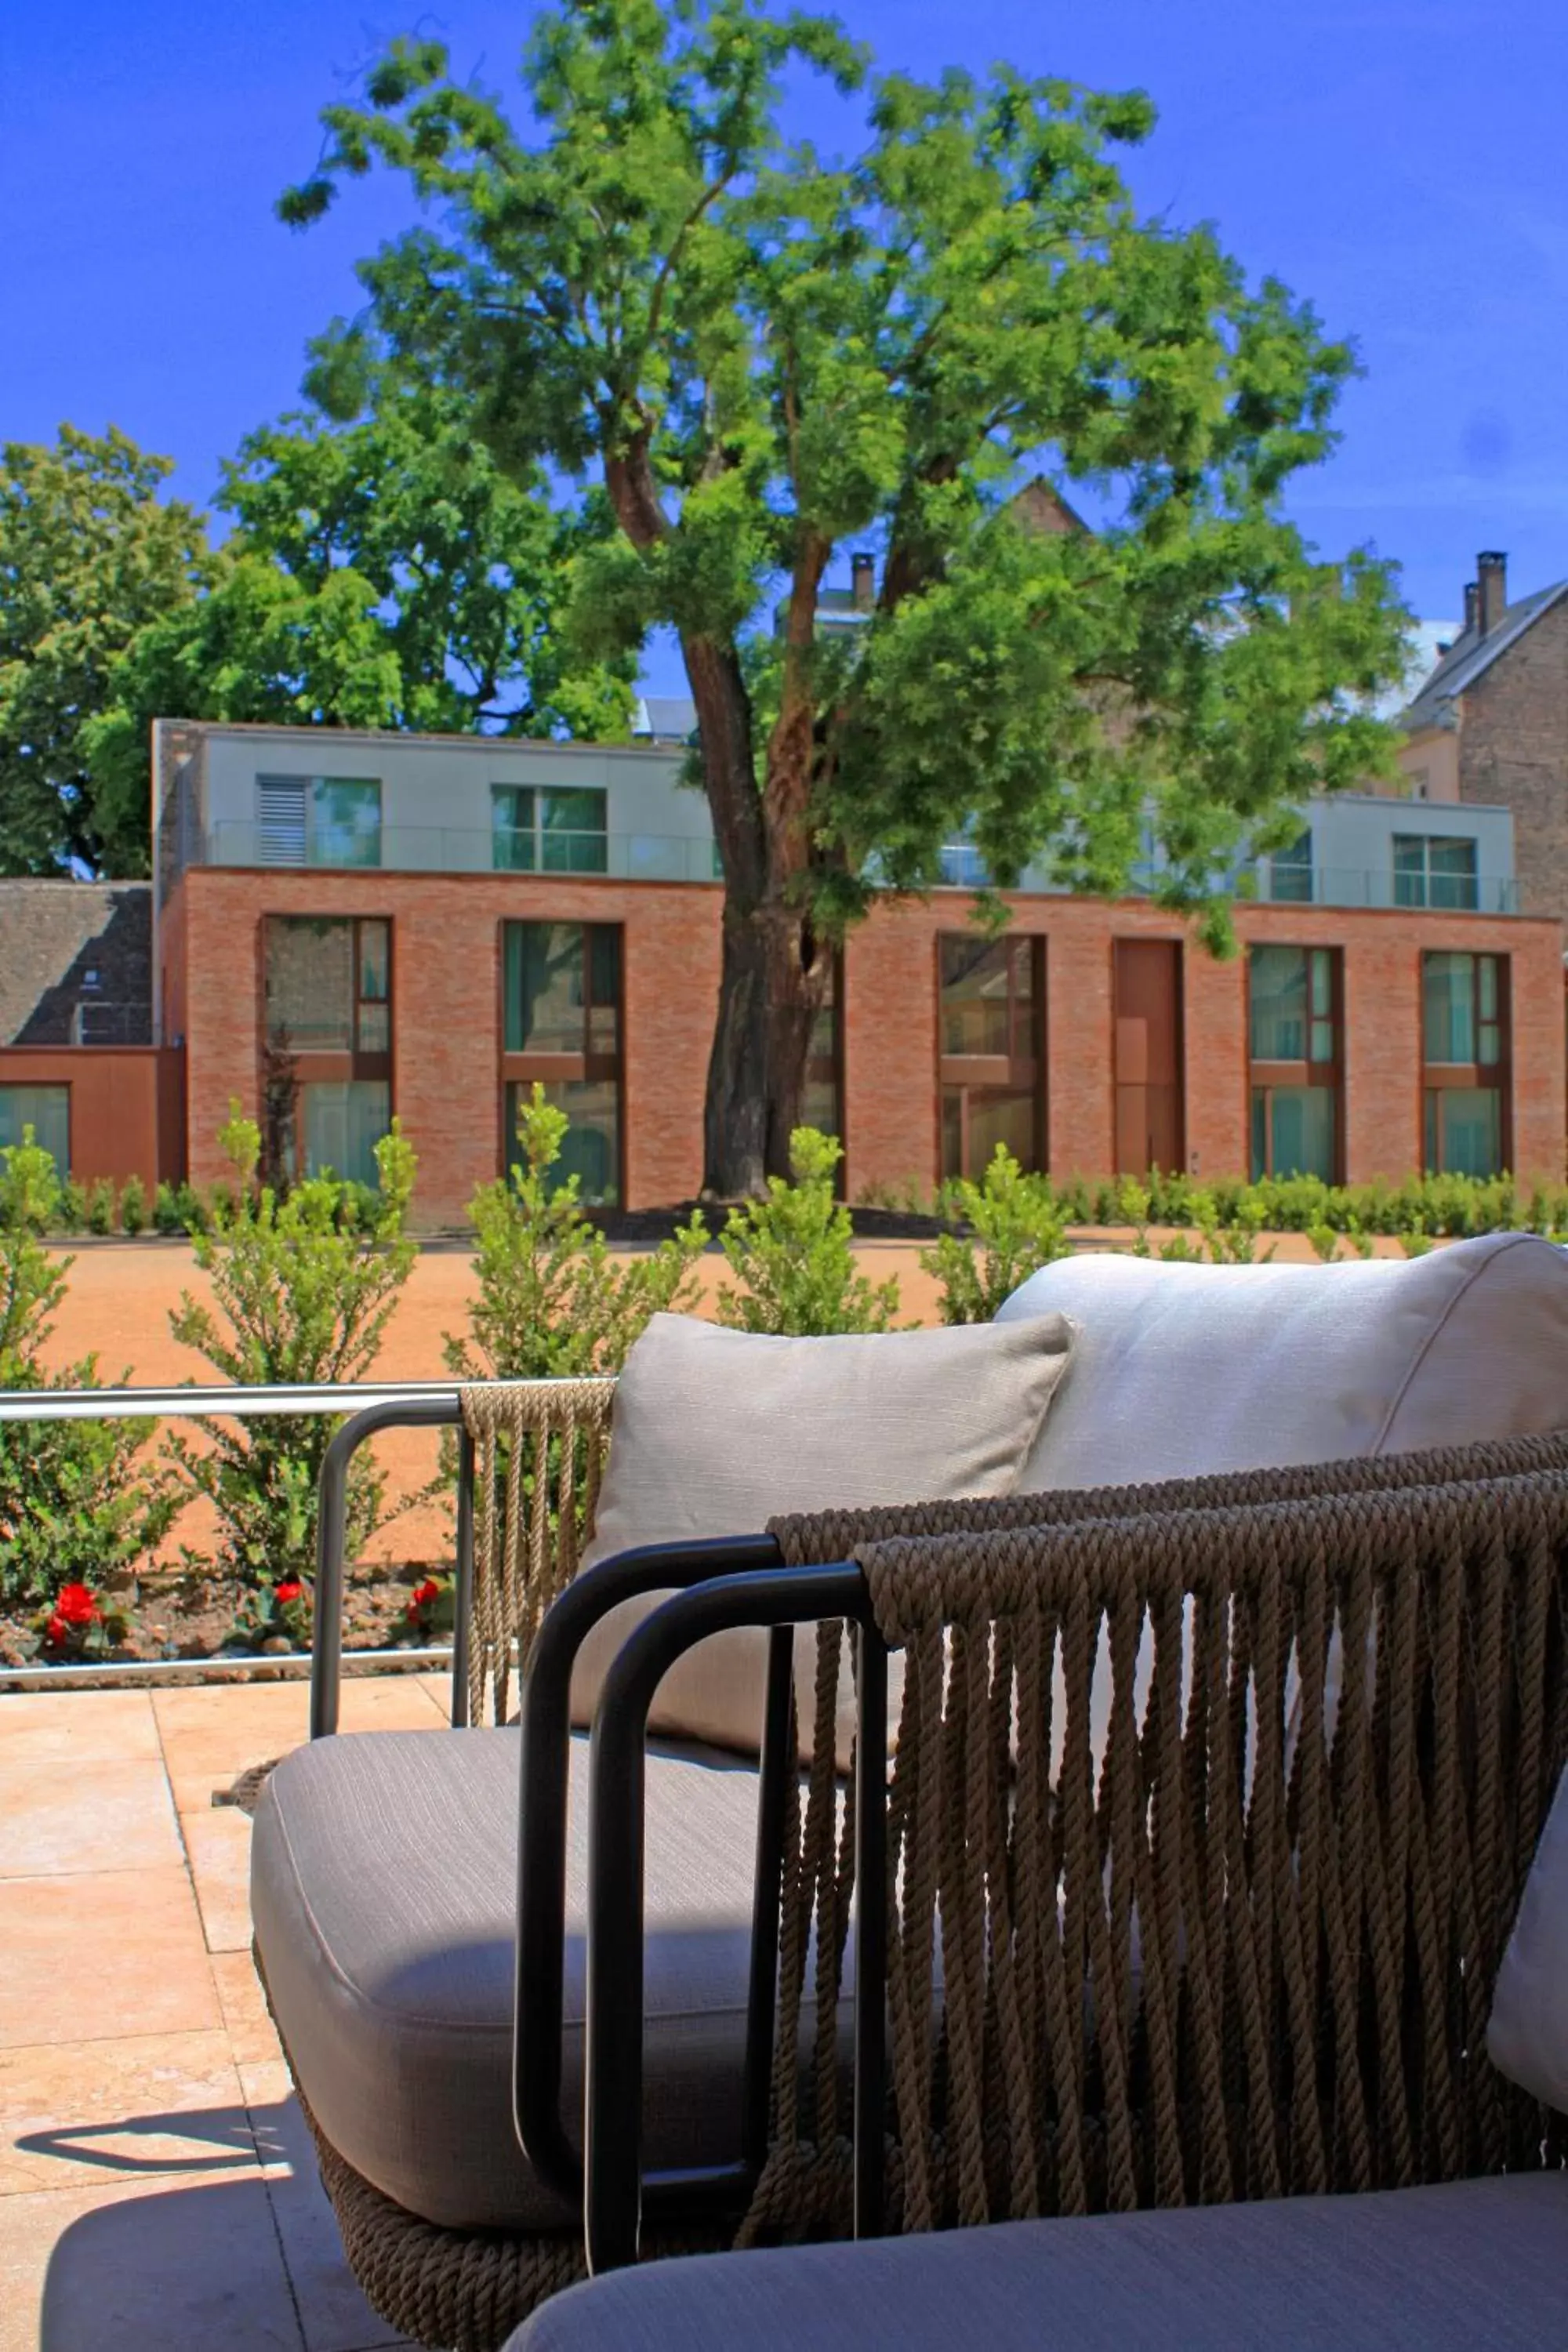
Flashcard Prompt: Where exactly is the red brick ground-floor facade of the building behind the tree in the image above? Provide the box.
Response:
[165,868,1563,1223]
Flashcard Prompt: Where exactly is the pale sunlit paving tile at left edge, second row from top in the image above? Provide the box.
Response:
[0,1757,179,1879]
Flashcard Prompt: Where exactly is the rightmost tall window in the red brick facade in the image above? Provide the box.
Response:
[1420,953,1512,1176]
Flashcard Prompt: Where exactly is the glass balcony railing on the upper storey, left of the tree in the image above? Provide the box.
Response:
[193,821,720,882]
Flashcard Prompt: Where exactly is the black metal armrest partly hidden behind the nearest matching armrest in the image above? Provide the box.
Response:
[513,1536,792,2204]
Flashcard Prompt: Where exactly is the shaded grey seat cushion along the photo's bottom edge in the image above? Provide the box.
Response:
[506,2173,1568,2352]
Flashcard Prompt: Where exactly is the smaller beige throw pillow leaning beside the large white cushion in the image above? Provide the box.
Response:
[572,1315,1072,1762]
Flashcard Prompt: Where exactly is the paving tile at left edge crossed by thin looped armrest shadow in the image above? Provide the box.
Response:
[0,2032,256,2192]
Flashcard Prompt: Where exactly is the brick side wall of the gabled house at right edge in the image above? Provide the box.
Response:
[1460,597,1568,917]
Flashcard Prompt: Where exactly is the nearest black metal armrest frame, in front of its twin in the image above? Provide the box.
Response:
[586,1564,888,2272]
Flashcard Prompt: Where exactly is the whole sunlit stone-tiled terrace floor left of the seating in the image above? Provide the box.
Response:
[0,1675,460,2352]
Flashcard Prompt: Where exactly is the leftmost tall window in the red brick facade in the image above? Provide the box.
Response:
[261,915,393,1183]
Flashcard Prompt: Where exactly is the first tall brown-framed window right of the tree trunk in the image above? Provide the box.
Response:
[938,931,1046,1176]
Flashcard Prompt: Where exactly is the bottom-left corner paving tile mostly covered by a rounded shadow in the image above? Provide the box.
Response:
[0,2166,303,2352]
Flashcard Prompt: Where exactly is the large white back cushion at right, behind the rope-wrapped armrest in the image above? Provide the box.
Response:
[996,1232,1568,1494]
